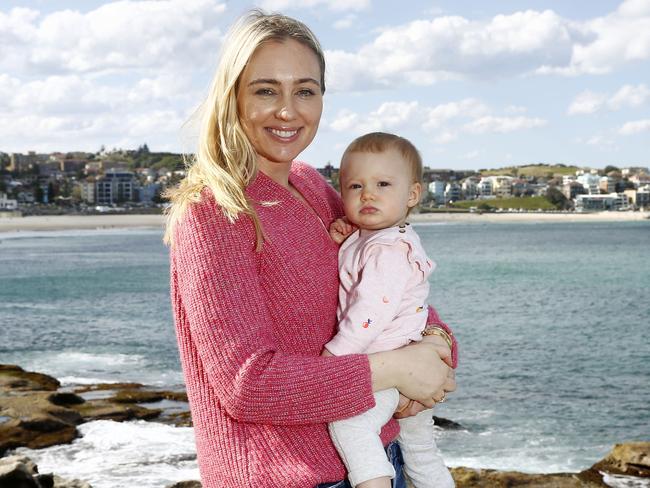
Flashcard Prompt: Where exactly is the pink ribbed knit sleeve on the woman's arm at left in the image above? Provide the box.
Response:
[171,201,374,425]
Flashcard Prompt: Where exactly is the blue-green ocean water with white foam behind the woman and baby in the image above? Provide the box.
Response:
[0,221,650,488]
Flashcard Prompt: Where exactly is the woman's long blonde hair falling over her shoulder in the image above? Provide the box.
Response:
[164,9,325,250]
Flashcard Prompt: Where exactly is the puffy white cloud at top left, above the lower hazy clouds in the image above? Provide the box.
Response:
[0,0,226,74]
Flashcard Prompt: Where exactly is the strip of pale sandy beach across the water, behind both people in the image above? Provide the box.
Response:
[0,212,650,232]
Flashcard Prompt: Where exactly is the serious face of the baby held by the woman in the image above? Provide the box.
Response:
[340,149,421,230]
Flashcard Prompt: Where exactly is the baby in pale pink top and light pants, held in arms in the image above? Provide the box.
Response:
[323,132,454,488]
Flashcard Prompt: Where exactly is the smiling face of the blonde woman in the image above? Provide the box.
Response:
[237,39,323,171]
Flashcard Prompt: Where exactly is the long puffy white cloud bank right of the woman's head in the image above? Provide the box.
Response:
[326,0,650,91]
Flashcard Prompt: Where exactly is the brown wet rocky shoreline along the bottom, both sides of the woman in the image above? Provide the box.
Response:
[0,365,650,488]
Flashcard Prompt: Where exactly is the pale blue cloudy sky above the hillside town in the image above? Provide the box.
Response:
[0,0,650,170]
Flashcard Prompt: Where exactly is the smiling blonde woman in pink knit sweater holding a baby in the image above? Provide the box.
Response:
[165,11,455,488]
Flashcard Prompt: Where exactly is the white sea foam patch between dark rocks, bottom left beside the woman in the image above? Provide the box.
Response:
[18,420,199,488]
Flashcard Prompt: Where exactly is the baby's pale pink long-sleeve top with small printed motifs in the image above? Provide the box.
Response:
[325,225,435,356]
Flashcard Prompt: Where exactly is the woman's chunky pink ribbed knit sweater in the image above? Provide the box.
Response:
[170,163,458,488]
